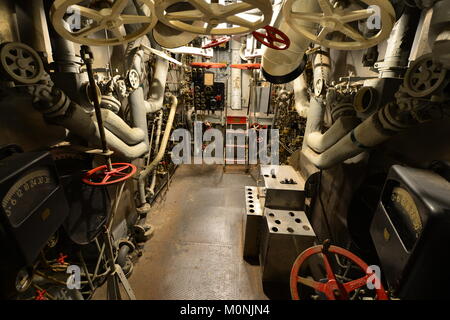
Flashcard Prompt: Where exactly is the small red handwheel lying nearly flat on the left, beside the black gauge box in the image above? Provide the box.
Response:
[82,163,137,186]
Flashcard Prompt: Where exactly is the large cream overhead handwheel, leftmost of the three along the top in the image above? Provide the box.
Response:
[50,0,158,46]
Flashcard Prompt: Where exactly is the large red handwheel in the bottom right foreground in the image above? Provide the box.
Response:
[290,245,388,300]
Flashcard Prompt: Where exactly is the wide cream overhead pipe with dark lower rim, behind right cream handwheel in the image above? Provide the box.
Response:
[262,0,319,84]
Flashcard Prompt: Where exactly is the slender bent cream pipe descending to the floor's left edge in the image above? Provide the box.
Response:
[139,95,178,205]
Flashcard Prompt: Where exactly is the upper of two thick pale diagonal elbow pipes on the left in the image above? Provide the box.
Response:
[101,109,145,145]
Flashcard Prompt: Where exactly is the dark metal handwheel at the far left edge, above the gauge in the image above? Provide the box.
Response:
[0,42,44,84]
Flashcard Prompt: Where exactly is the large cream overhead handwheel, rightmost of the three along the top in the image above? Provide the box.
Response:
[283,0,395,50]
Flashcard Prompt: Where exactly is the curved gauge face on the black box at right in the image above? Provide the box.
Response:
[386,187,423,251]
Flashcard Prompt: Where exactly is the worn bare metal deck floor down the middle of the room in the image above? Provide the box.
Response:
[125,165,267,300]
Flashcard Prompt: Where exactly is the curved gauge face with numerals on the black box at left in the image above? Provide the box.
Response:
[2,168,57,228]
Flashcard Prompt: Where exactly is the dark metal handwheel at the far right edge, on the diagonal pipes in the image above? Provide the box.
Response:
[403,53,447,98]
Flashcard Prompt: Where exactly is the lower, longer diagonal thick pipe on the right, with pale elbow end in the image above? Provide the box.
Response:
[302,104,412,169]
